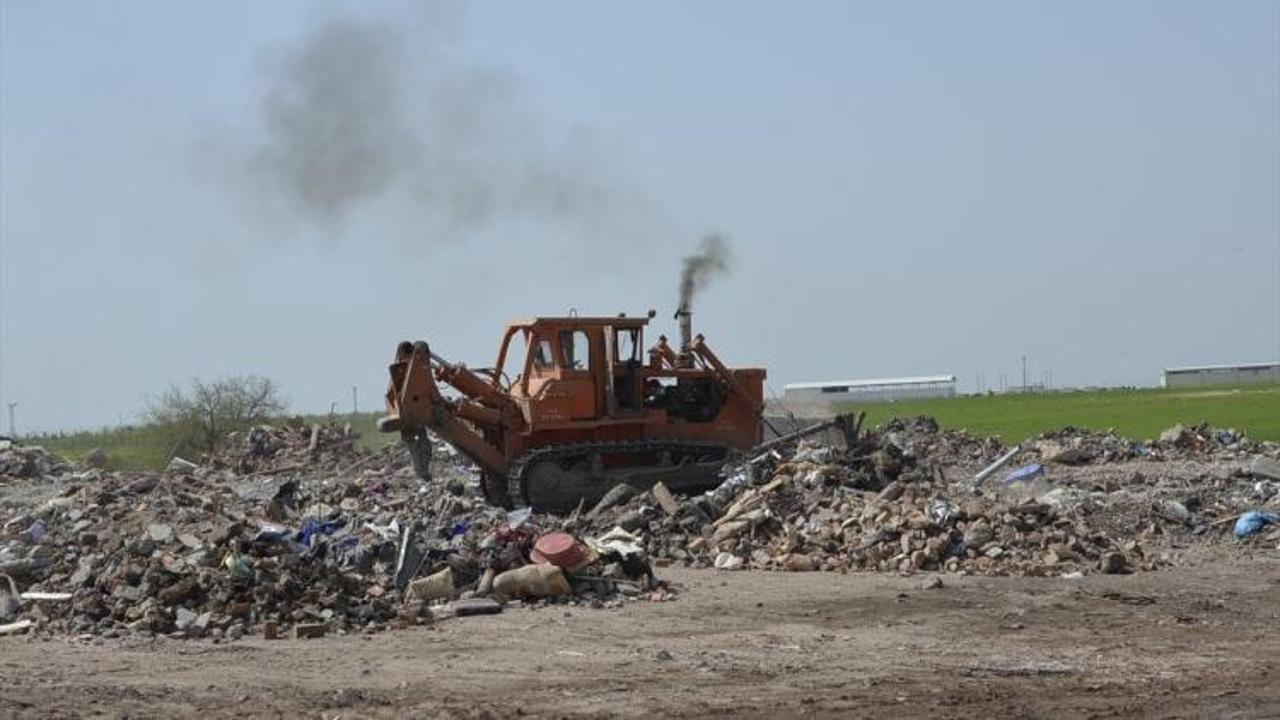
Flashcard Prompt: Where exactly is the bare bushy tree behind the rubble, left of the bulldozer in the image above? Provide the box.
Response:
[146,375,287,451]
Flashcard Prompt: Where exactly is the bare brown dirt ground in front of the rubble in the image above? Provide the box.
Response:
[0,548,1280,719]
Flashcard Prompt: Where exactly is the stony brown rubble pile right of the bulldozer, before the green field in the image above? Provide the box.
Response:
[578,419,1280,575]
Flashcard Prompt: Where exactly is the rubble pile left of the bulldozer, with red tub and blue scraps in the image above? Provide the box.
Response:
[0,428,671,639]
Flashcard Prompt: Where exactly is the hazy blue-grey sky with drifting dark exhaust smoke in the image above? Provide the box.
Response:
[0,0,1280,430]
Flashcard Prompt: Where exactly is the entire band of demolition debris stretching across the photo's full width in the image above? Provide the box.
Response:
[0,418,1280,639]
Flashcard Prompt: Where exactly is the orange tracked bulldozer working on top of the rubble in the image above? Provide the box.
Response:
[379,305,764,511]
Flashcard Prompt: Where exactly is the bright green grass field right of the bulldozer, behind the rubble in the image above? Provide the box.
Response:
[842,386,1280,443]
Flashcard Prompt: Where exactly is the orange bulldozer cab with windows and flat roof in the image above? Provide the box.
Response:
[494,316,648,424]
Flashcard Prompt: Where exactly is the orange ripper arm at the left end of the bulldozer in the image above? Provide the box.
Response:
[378,342,507,475]
